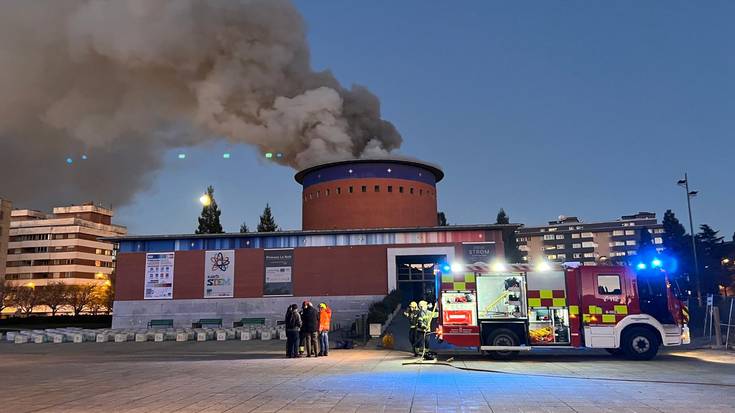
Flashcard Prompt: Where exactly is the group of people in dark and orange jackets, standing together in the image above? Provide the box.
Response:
[285,300,332,358]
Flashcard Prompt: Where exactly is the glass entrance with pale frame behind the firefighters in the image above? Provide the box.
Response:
[396,255,447,307]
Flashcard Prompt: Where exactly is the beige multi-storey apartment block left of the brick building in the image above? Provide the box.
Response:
[5,203,127,286]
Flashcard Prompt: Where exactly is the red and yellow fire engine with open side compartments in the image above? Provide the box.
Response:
[436,258,690,360]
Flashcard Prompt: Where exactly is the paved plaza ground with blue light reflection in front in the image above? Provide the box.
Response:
[0,341,735,413]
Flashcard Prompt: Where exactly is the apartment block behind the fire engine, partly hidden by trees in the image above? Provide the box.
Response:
[516,212,664,265]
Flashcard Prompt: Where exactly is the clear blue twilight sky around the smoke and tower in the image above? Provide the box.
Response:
[116,0,735,240]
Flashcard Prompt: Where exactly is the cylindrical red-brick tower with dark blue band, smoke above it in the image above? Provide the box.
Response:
[295,159,444,230]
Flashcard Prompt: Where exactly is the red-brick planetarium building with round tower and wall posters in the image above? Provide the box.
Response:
[113,158,505,328]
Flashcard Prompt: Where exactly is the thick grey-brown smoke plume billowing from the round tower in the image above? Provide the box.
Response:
[0,0,401,208]
